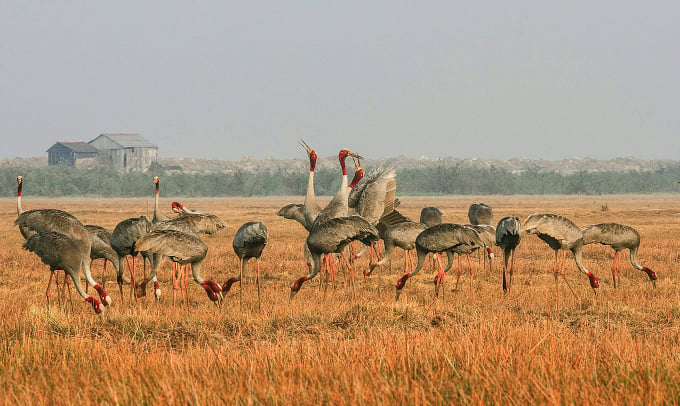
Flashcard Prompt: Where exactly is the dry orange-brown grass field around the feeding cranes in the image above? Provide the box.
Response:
[0,195,680,405]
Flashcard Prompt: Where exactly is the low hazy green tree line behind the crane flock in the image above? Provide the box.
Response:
[0,164,680,197]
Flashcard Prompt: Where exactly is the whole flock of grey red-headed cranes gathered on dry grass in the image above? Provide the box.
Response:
[15,140,657,313]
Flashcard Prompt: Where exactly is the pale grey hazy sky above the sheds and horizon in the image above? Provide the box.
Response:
[0,0,680,160]
